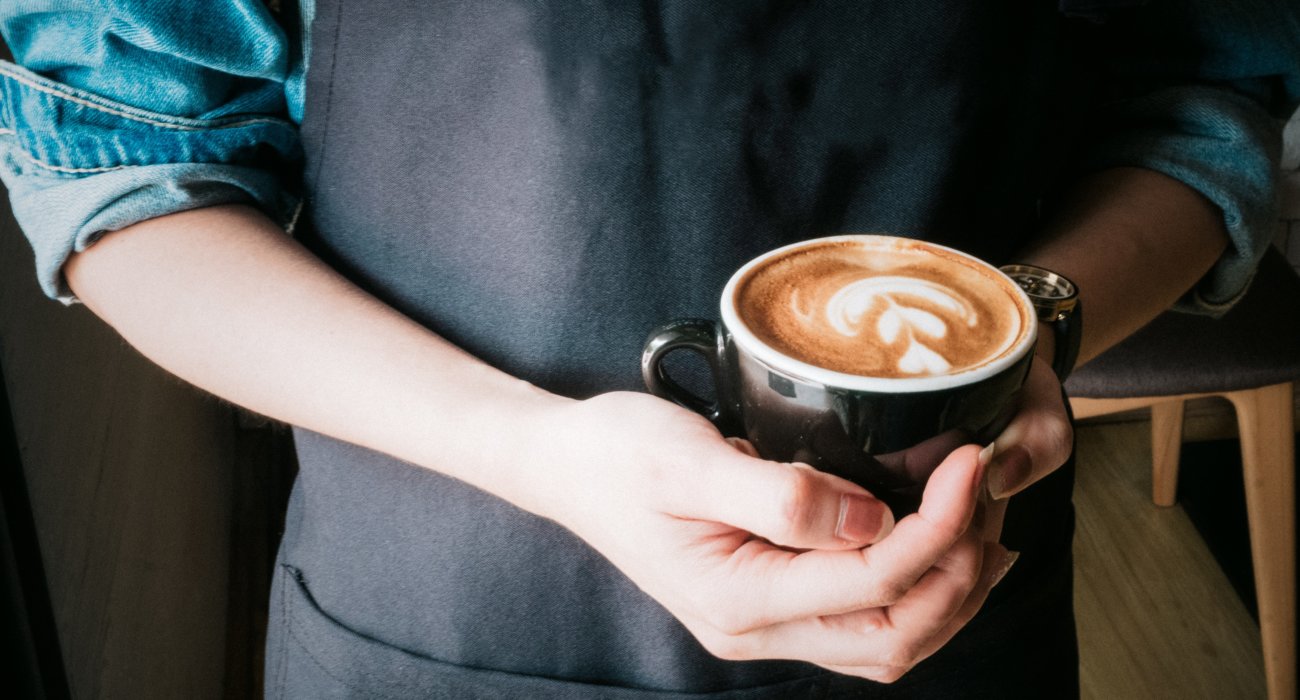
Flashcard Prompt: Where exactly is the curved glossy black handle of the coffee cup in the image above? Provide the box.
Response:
[641,319,735,433]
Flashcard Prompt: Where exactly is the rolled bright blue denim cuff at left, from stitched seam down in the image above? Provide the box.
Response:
[0,61,302,303]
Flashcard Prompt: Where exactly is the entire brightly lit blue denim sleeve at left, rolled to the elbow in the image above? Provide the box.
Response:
[0,0,300,303]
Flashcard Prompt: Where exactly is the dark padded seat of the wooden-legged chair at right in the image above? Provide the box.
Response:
[1066,247,1300,398]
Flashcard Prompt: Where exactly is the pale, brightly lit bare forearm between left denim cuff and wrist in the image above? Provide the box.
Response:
[66,207,564,507]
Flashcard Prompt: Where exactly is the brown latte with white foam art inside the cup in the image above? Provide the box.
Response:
[732,236,1031,379]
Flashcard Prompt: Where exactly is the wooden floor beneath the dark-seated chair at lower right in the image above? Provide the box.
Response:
[1074,422,1265,700]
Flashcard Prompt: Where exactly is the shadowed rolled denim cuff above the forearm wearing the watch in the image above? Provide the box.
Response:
[1082,80,1282,316]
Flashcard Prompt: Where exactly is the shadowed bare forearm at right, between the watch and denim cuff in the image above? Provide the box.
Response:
[1024,168,1229,364]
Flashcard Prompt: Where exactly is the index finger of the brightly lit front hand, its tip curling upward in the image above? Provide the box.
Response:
[701,445,983,634]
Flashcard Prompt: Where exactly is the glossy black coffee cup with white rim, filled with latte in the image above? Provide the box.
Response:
[641,234,1037,515]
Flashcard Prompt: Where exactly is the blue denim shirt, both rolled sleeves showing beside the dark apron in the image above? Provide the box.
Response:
[0,0,1300,307]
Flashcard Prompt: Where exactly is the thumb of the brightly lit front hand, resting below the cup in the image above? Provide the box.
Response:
[680,441,894,549]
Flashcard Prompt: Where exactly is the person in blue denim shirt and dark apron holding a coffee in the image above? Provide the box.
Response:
[0,0,1300,697]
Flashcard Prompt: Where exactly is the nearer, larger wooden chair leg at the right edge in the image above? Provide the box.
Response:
[1227,383,1296,700]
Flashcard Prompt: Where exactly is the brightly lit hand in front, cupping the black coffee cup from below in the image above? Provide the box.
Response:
[516,393,1010,682]
